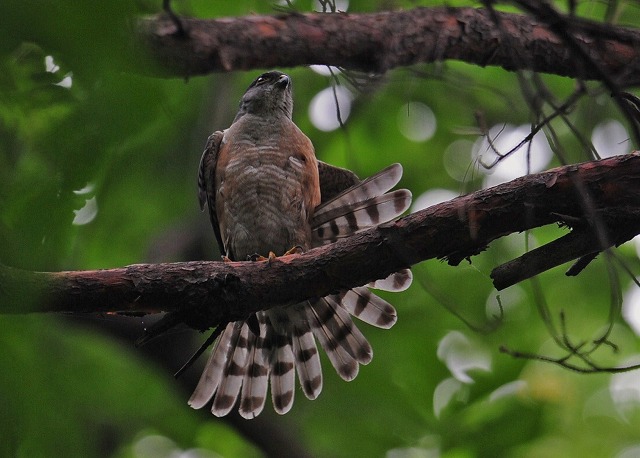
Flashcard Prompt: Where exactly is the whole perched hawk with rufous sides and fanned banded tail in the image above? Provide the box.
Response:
[189,71,412,419]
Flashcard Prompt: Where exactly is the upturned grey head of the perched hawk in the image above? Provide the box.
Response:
[234,71,293,122]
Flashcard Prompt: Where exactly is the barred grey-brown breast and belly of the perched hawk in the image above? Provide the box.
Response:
[216,133,317,260]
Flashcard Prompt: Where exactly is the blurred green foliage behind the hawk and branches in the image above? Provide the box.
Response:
[0,0,640,458]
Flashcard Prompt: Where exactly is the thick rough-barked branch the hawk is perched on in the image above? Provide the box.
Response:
[0,153,640,327]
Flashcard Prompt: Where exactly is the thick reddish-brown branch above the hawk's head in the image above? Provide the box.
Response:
[137,8,640,86]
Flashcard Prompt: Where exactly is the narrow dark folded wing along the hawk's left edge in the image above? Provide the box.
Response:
[198,131,226,254]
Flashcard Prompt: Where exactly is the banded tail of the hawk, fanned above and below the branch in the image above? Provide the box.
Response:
[189,164,412,418]
